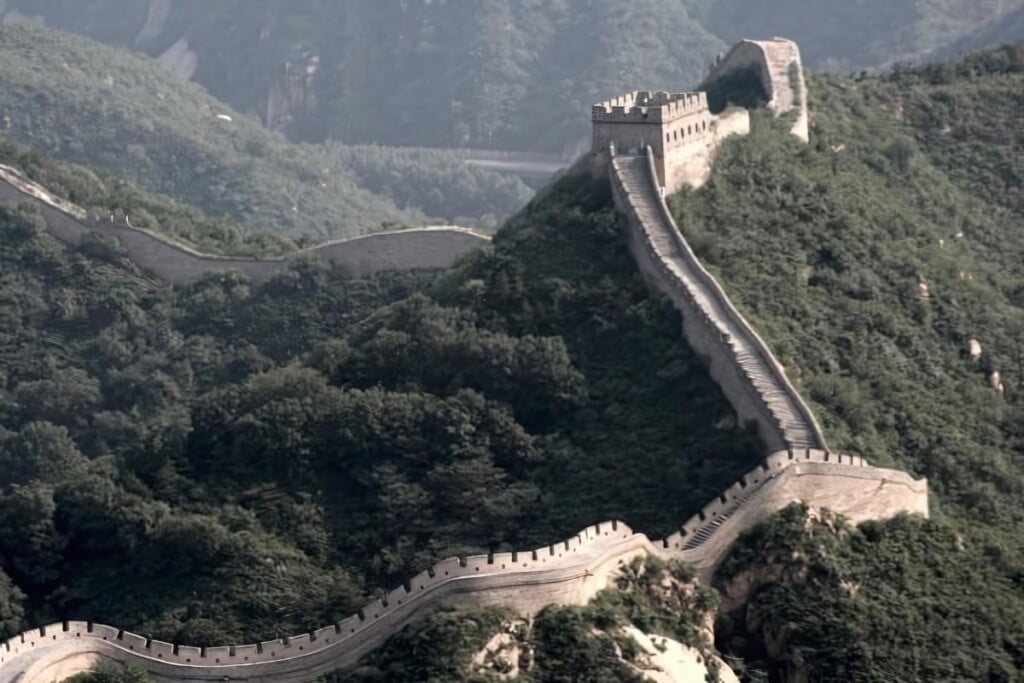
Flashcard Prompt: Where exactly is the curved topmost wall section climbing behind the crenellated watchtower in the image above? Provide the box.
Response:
[700,38,810,142]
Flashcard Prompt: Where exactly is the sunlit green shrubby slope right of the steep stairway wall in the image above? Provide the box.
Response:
[672,46,1024,525]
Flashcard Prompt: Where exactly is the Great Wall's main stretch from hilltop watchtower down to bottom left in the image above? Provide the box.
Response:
[0,40,928,683]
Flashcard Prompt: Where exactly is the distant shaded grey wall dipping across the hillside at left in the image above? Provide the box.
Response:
[0,165,490,285]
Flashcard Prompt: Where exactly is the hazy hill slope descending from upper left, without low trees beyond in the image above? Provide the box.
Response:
[0,20,424,237]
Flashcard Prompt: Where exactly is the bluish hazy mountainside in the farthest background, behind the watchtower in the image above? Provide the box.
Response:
[0,0,1024,152]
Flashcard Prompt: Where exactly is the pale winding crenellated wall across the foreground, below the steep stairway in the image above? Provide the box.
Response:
[0,450,928,683]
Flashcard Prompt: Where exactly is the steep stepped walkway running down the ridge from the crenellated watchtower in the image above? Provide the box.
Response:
[611,156,826,450]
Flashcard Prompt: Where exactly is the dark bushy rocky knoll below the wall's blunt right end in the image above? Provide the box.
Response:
[716,505,1024,683]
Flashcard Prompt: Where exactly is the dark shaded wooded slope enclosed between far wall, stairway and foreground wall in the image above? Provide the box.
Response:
[0,152,761,644]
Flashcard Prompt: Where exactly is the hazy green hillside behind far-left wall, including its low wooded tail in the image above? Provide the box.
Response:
[0,26,531,240]
